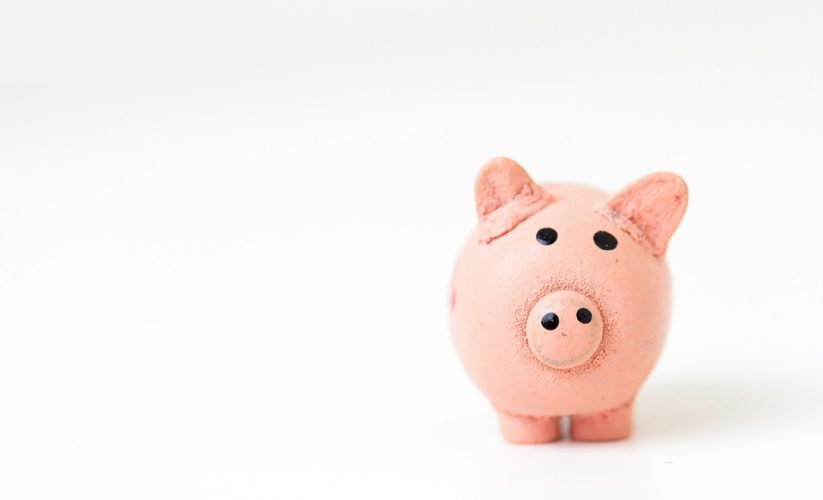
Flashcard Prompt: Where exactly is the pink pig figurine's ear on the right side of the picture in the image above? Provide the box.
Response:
[606,172,689,257]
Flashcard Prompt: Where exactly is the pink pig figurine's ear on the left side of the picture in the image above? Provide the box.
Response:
[474,157,554,243]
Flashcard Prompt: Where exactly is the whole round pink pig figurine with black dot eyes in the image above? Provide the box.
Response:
[450,158,688,443]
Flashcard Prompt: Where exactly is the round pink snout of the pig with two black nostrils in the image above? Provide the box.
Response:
[526,290,603,369]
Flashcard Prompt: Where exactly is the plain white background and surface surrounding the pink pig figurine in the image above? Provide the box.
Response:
[0,0,823,500]
